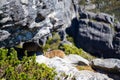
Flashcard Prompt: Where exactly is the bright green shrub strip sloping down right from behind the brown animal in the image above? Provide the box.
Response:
[59,44,94,60]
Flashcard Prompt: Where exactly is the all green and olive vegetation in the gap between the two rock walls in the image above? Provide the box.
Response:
[43,33,94,60]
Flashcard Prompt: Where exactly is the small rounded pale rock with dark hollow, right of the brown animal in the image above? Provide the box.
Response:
[64,54,89,66]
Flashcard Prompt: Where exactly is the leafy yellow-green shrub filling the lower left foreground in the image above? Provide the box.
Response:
[0,48,56,80]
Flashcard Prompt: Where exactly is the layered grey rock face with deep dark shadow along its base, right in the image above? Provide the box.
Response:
[66,11,120,58]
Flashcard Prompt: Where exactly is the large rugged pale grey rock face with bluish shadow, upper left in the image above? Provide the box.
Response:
[0,0,75,47]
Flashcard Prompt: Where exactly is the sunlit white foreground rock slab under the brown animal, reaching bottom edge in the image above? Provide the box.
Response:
[36,55,113,80]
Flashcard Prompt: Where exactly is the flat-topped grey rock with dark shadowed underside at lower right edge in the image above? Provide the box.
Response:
[91,58,120,80]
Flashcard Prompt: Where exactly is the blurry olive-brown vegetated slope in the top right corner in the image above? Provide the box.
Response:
[91,0,120,21]
